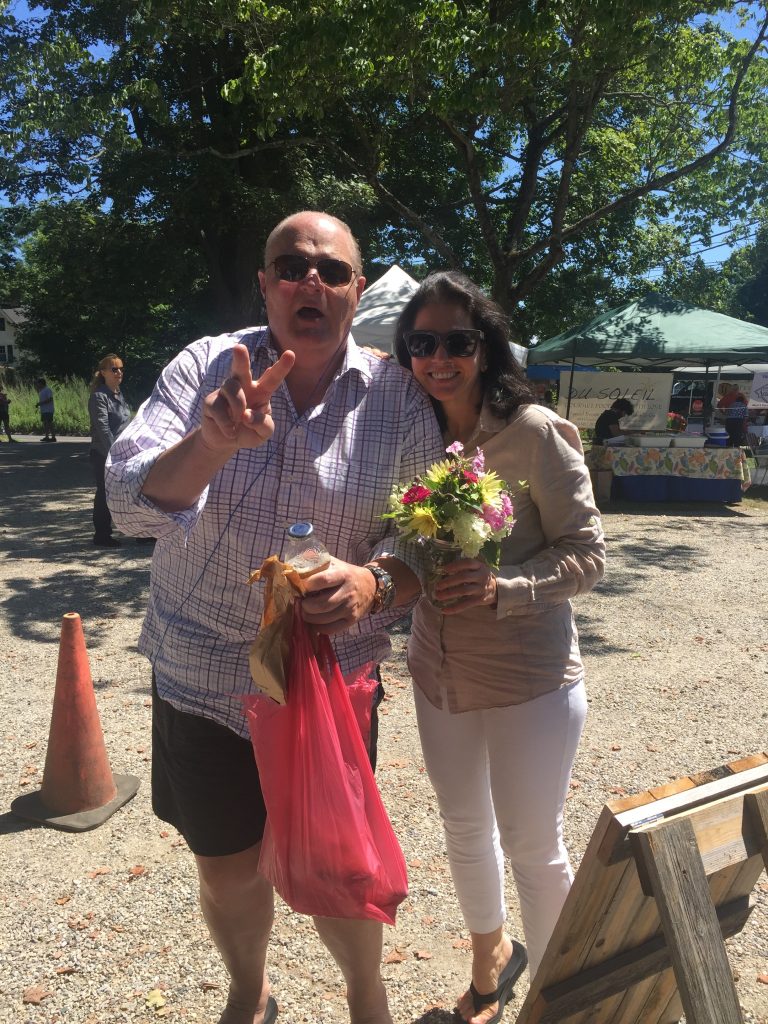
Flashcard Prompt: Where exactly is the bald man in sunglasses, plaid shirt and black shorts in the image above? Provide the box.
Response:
[106,212,442,1024]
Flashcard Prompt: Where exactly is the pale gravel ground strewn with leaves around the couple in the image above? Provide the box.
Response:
[0,441,768,1024]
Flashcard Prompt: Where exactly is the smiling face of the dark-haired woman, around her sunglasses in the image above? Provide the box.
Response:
[411,303,484,409]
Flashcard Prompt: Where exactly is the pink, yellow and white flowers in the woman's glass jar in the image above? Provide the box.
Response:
[382,441,513,568]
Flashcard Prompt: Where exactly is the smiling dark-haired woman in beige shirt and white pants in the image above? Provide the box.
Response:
[395,271,604,1024]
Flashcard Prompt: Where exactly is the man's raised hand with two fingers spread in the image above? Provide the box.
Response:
[201,345,296,452]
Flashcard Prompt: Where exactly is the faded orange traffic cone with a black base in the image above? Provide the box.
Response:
[10,611,139,831]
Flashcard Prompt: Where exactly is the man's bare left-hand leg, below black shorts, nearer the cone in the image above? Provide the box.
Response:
[195,844,274,1024]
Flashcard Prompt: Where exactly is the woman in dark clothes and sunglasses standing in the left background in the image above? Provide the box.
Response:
[88,352,131,548]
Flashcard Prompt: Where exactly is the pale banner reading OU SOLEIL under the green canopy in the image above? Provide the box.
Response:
[557,371,673,430]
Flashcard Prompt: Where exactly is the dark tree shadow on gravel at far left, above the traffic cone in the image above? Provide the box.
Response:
[0,441,152,646]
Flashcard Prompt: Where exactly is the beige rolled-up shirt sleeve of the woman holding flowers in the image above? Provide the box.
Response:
[498,419,605,617]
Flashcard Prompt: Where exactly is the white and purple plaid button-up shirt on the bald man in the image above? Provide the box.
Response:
[106,328,442,736]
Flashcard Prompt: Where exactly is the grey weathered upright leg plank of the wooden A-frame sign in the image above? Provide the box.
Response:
[631,818,743,1024]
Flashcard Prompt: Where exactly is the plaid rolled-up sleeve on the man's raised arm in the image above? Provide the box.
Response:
[105,338,214,538]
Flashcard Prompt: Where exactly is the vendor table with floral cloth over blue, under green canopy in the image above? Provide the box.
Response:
[586,444,751,503]
